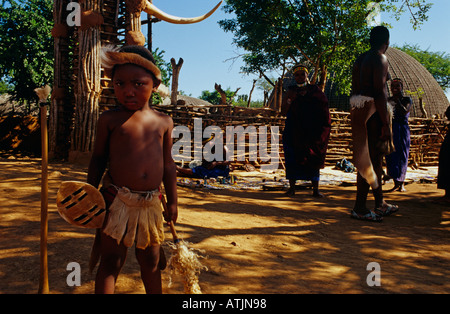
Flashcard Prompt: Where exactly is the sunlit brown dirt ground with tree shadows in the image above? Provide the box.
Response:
[0,158,450,294]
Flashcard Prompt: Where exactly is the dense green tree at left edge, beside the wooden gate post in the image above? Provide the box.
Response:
[0,0,53,108]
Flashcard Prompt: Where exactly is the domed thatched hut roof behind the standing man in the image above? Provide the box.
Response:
[325,47,450,117]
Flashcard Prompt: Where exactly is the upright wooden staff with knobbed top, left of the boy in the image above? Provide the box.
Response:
[34,85,50,294]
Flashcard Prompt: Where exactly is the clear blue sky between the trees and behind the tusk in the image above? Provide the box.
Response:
[146,0,450,100]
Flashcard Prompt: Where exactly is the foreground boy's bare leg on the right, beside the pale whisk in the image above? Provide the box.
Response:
[136,245,162,294]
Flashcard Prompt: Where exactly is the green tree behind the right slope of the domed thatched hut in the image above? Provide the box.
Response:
[397,44,450,91]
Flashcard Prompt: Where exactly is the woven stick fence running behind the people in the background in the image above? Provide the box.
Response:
[153,106,449,168]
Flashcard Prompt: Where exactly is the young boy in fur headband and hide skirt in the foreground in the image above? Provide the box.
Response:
[87,46,178,293]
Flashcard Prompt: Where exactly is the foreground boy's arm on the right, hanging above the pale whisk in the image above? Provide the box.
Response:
[163,118,178,223]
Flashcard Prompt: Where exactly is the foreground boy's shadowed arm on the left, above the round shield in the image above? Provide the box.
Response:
[87,115,109,188]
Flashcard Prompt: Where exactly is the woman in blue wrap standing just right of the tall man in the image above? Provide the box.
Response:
[386,78,412,192]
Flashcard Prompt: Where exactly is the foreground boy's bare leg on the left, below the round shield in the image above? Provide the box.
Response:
[95,232,127,294]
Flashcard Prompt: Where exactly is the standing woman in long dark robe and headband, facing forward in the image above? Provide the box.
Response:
[281,65,331,197]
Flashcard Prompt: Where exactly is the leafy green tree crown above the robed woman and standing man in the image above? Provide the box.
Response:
[219,0,431,94]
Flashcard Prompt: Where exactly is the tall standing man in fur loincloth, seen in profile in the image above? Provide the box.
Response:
[350,26,398,221]
